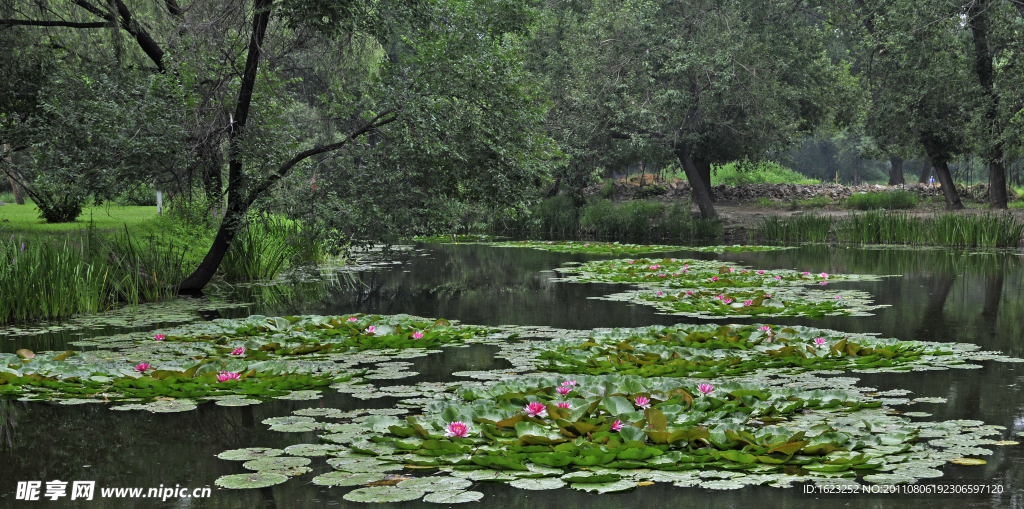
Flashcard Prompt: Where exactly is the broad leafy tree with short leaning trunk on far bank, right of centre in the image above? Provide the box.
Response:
[540,0,860,217]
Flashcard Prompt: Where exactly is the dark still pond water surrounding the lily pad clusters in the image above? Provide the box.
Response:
[0,244,1024,503]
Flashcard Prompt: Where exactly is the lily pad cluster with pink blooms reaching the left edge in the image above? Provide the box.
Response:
[0,314,498,412]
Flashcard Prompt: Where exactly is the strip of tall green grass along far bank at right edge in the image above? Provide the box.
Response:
[757,211,1024,248]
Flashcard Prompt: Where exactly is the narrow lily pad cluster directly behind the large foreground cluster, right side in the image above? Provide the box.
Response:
[526,324,1019,378]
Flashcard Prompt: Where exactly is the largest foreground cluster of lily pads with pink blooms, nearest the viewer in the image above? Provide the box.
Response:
[209,375,1009,503]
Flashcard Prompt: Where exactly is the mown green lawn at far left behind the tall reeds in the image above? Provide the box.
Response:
[0,203,157,234]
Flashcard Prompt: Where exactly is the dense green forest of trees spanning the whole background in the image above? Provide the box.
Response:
[0,0,1024,291]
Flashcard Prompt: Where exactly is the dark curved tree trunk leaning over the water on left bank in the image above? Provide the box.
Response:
[178,0,273,293]
